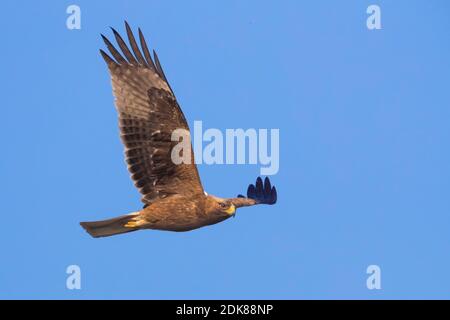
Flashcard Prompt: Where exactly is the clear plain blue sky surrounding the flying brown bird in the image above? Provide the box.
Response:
[0,0,450,299]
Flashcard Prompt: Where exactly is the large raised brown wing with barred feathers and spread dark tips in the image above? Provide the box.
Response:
[100,22,203,205]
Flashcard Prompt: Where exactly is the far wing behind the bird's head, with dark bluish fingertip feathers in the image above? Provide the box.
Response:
[232,177,277,208]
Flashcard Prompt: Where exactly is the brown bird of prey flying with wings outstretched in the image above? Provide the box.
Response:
[80,22,277,237]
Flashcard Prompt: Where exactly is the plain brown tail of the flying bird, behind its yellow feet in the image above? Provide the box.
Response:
[80,212,139,238]
